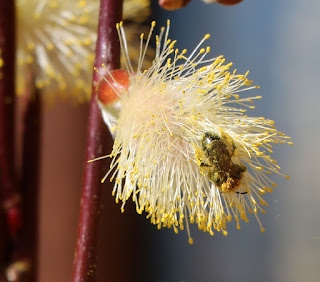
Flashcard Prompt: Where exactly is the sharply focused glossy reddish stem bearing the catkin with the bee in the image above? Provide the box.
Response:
[72,0,122,282]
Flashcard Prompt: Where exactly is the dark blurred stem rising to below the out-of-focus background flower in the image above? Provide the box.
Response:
[9,85,42,282]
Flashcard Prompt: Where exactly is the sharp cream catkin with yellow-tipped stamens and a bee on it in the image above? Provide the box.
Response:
[99,21,291,243]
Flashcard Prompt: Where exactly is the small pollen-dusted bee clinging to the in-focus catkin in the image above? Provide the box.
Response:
[194,131,247,194]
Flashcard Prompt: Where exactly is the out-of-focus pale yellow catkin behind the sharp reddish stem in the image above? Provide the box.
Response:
[16,0,149,102]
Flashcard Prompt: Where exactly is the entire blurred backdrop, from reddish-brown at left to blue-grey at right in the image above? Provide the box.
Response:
[39,0,320,282]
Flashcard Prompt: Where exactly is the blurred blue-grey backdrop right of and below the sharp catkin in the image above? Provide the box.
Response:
[132,0,320,282]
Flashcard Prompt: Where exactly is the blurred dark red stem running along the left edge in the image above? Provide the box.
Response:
[0,0,19,268]
